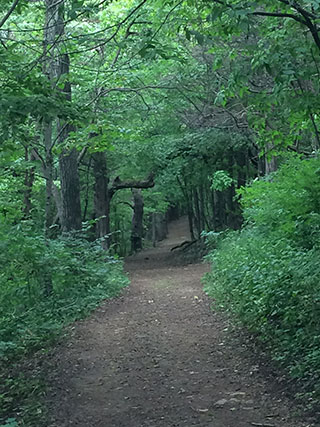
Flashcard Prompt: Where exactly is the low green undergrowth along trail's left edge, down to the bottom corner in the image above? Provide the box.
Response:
[0,223,128,427]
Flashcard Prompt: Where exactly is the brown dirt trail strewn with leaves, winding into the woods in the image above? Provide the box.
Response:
[48,220,311,427]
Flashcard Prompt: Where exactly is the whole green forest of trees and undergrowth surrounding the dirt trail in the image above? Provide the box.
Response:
[0,0,320,427]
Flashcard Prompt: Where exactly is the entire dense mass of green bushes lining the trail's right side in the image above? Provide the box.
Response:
[205,157,320,399]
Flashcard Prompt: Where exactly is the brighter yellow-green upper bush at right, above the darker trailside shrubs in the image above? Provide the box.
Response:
[239,157,320,248]
